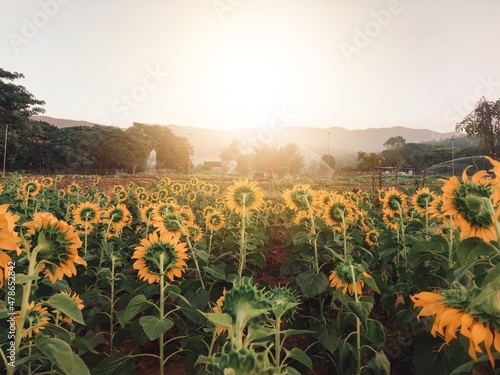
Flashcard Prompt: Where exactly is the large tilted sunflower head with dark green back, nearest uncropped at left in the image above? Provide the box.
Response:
[23,212,87,283]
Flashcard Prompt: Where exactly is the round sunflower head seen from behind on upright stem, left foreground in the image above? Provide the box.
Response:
[132,231,189,284]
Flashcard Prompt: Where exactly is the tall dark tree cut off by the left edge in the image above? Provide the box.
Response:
[0,68,45,175]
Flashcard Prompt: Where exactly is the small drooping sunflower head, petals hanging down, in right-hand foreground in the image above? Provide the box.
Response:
[328,260,371,296]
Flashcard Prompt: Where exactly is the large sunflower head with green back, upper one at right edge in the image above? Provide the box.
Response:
[441,169,500,242]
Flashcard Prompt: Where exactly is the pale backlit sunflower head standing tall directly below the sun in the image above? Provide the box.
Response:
[225,180,264,214]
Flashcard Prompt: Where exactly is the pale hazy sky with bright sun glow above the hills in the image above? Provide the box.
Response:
[0,0,500,132]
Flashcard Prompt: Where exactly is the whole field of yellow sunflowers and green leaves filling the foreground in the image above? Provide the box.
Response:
[0,159,500,375]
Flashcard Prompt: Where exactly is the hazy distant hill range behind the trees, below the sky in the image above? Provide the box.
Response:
[33,116,464,164]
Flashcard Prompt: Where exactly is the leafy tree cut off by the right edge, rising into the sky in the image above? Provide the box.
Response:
[455,96,500,158]
